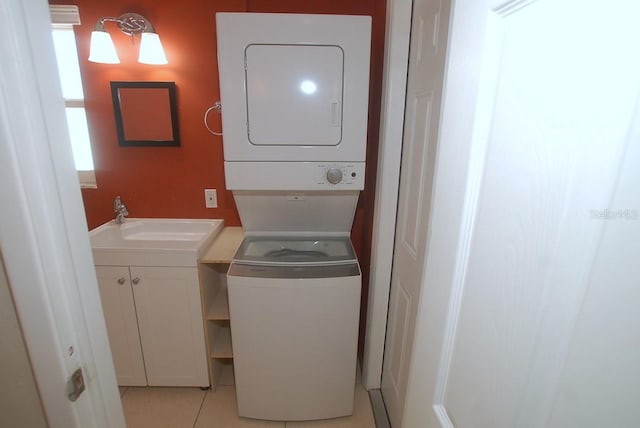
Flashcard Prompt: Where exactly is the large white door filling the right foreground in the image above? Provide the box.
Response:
[393,0,640,428]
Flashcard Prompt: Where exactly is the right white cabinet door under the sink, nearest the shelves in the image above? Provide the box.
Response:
[130,267,209,386]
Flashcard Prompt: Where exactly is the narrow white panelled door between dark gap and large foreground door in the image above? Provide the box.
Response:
[382,0,450,427]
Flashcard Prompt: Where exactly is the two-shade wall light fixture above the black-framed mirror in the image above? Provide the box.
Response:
[89,13,167,65]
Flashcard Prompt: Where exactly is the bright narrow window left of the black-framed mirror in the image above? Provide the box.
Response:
[49,6,96,188]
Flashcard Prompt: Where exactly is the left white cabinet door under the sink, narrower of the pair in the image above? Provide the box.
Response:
[96,266,147,386]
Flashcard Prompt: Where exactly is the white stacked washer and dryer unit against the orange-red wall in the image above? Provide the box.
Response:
[216,13,371,421]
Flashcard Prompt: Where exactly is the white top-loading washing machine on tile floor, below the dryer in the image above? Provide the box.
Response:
[227,236,361,421]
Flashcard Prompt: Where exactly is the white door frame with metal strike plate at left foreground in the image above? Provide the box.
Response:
[0,0,125,428]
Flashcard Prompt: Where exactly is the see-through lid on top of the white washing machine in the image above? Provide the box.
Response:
[234,236,356,265]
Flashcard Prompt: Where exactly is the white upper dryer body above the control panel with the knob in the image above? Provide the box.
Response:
[216,12,371,164]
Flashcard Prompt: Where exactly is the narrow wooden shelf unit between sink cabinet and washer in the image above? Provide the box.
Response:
[198,227,244,389]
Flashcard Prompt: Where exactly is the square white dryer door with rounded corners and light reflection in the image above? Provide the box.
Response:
[245,44,344,146]
